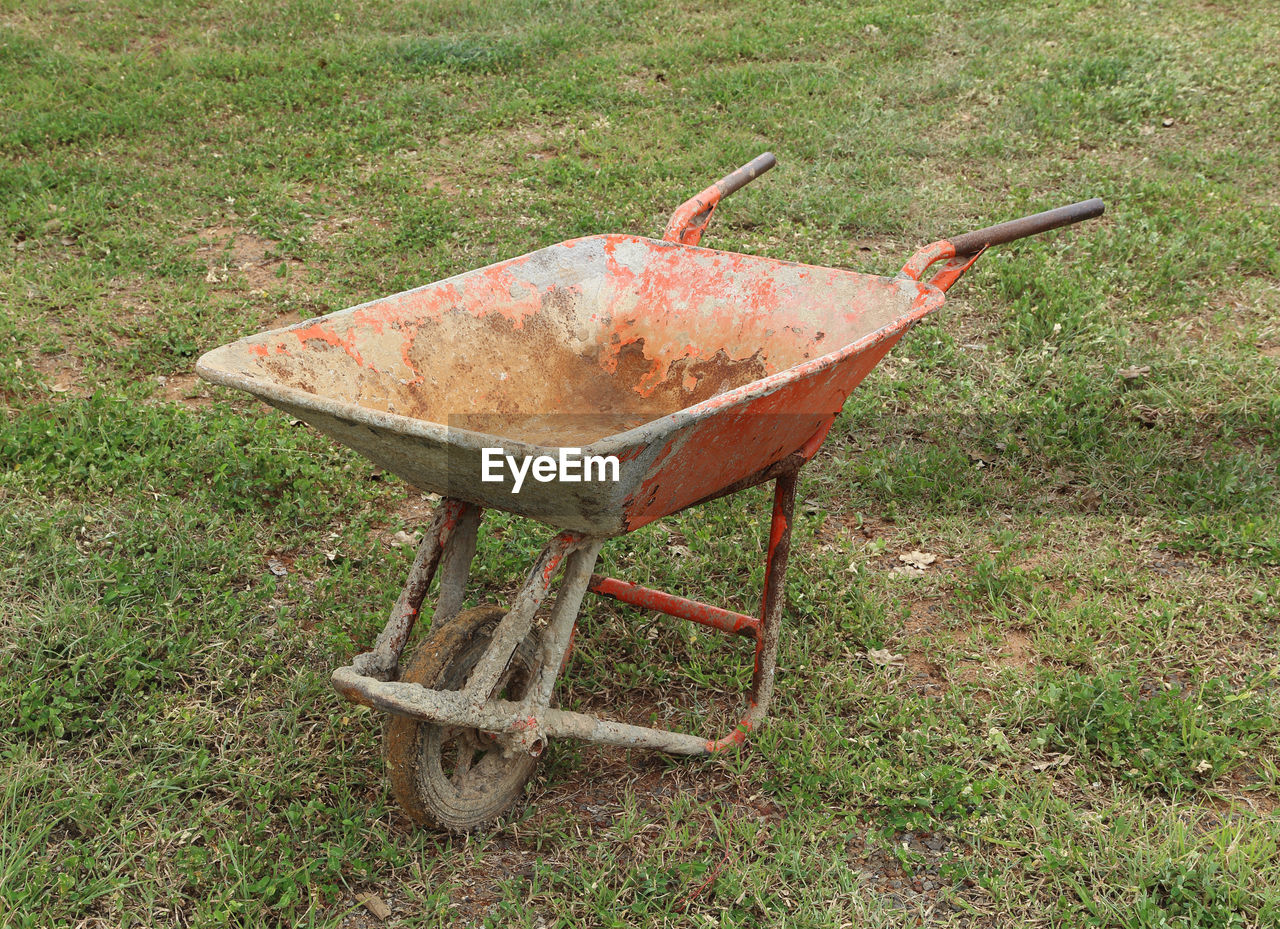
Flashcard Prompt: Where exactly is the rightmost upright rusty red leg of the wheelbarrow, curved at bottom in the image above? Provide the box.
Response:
[707,470,799,752]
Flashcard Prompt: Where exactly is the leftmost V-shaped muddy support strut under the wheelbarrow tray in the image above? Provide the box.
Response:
[352,499,481,681]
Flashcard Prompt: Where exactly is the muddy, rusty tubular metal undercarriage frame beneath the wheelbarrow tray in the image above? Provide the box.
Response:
[333,463,798,755]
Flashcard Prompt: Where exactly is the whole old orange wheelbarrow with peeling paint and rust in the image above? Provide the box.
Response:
[197,154,1103,832]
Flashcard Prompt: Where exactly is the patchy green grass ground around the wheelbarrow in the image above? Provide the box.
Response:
[0,0,1280,929]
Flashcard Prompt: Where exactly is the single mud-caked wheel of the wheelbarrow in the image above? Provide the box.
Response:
[383,607,538,832]
